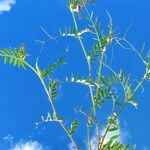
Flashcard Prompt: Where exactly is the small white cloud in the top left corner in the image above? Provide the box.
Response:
[0,0,16,13]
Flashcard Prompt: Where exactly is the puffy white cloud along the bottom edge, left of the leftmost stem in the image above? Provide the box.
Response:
[10,141,43,150]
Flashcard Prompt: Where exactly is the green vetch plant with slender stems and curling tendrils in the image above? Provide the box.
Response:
[0,0,150,150]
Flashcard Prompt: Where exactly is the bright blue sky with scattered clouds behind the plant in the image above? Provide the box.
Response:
[0,0,150,150]
